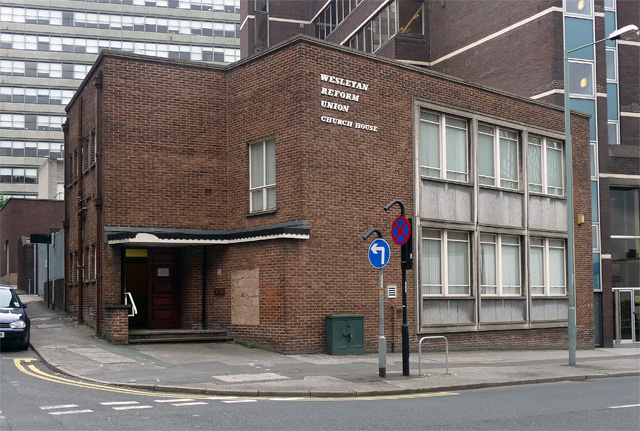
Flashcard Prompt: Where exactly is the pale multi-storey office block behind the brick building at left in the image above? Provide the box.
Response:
[0,0,240,199]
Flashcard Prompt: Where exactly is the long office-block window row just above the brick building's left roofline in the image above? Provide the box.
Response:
[0,33,240,63]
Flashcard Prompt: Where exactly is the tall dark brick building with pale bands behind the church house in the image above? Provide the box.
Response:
[241,0,640,346]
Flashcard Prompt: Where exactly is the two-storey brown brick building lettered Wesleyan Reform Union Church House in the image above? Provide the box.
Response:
[65,36,593,352]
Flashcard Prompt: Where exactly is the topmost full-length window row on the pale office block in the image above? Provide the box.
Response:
[0,6,240,38]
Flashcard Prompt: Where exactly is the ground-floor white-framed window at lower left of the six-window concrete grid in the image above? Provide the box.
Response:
[421,229,471,296]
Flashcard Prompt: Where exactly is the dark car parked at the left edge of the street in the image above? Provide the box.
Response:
[0,284,31,350]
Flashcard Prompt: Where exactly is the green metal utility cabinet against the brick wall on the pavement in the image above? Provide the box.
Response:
[326,314,364,355]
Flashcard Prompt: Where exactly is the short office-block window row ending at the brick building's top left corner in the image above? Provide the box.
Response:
[0,60,92,79]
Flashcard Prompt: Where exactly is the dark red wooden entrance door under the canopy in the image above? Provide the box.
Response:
[149,248,181,329]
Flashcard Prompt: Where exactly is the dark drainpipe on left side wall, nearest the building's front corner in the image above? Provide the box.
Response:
[93,71,104,336]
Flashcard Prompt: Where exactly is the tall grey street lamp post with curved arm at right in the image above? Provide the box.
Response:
[564,24,640,365]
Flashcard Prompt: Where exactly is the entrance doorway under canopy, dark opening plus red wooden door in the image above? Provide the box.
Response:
[123,248,180,329]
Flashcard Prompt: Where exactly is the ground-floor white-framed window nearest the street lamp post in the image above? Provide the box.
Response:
[529,238,567,296]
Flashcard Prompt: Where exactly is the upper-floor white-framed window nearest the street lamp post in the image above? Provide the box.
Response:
[528,135,564,196]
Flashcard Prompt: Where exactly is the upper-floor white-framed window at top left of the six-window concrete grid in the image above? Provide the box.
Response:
[420,111,469,182]
